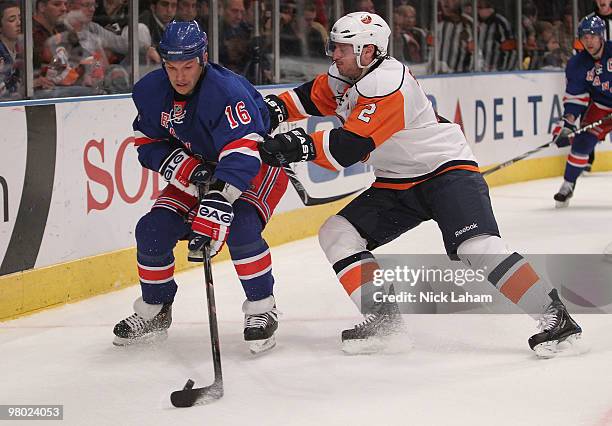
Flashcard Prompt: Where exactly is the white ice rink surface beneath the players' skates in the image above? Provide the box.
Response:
[0,173,612,426]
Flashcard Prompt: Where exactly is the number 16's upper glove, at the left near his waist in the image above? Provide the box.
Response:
[159,148,212,197]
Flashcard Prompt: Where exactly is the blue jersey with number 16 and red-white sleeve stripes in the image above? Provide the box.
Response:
[132,63,269,191]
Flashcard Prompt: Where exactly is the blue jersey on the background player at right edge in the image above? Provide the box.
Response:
[563,41,612,117]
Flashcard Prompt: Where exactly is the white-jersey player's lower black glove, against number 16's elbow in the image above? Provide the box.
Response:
[259,127,317,167]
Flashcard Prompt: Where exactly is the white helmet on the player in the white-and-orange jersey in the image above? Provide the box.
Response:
[325,12,391,68]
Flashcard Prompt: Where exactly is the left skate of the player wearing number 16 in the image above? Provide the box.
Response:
[113,297,172,346]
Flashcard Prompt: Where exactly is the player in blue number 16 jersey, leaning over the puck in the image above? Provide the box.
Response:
[114,21,287,352]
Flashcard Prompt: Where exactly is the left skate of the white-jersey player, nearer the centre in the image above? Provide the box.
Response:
[342,303,405,355]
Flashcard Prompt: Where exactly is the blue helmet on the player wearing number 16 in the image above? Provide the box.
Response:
[159,21,208,61]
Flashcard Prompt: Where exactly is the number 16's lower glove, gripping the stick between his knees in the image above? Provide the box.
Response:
[189,191,234,261]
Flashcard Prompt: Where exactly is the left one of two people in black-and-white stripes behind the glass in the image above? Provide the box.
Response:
[436,0,474,73]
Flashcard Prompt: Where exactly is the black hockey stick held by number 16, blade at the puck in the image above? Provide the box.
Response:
[170,187,223,407]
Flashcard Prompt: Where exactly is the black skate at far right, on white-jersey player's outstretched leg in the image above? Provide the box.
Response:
[529,289,582,358]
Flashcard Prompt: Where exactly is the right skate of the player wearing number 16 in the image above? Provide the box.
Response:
[242,296,278,354]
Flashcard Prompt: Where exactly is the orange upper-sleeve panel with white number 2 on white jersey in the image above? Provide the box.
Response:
[344,90,405,147]
